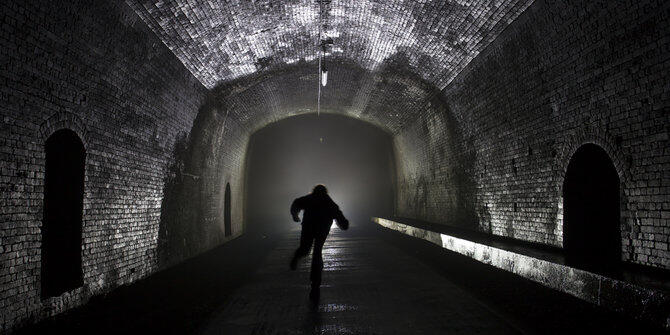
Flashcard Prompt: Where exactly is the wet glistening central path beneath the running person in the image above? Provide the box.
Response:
[204,228,519,334]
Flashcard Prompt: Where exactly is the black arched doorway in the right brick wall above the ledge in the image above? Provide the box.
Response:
[563,144,621,273]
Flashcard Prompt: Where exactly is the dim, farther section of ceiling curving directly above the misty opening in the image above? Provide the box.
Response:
[208,53,443,133]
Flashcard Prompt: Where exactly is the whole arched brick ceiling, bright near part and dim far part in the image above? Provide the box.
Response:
[127,0,532,131]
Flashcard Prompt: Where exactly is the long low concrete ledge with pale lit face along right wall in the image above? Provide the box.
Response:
[372,217,670,330]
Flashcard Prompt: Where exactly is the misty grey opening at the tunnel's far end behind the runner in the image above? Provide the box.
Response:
[246,113,395,231]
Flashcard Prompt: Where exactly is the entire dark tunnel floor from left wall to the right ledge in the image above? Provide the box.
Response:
[20,221,658,334]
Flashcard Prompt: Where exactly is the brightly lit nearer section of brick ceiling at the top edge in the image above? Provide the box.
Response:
[127,0,532,88]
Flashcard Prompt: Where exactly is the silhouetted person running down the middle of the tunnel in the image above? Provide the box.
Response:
[291,185,349,302]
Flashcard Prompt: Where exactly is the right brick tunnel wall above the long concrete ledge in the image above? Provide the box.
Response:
[395,0,670,269]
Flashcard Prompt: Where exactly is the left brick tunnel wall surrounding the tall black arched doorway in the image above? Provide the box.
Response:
[0,1,248,332]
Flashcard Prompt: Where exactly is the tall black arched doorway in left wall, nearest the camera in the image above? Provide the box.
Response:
[41,129,86,298]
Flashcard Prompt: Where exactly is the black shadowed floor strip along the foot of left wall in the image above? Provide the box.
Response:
[17,223,284,334]
